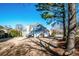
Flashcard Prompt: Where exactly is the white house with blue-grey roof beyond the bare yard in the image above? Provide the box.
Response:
[22,24,49,37]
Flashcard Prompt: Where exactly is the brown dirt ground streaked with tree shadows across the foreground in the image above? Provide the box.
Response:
[0,37,78,56]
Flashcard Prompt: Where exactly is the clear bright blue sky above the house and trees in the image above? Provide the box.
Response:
[0,3,79,28]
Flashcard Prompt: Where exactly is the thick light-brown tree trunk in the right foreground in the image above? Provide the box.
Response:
[66,3,76,55]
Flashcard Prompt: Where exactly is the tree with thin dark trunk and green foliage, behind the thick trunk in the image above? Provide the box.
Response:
[36,3,66,40]
